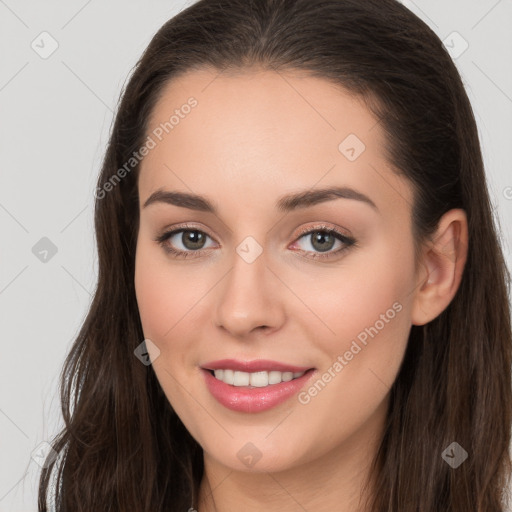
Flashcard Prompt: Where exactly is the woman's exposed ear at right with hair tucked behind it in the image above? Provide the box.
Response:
[411,209,468,325]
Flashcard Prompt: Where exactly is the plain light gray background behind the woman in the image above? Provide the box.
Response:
[0,0,512,512]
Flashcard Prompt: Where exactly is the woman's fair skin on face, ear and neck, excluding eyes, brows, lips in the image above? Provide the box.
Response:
[135,69,467,512]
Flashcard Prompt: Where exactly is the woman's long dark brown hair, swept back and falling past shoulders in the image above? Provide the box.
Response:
[39,0,512,512]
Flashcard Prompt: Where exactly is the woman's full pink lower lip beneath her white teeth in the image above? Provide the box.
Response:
[201,368,315,413]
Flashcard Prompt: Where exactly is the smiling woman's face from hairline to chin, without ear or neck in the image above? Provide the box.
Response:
[135,70,418,471]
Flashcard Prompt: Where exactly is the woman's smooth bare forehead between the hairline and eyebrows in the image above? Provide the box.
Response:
[139,69,411,218]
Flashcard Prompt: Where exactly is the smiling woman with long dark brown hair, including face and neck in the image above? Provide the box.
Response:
[39,0,512,512]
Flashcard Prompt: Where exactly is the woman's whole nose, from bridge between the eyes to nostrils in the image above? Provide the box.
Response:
[212,236,284,337]
